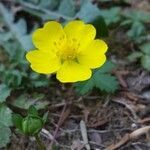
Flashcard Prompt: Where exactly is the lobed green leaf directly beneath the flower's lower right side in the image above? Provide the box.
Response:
[75,62,118,95]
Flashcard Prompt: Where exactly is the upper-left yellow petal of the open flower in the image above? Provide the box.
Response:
[32,21,66,51]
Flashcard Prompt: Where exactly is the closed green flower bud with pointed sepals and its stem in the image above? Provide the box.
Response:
[13,106,48,150]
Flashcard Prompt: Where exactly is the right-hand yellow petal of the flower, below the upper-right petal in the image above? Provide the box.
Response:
[77,40,108,69]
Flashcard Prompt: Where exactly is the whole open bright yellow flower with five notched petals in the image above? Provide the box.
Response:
[26,20,107,82]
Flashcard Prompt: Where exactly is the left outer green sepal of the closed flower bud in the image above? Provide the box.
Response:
[12,114,23,131]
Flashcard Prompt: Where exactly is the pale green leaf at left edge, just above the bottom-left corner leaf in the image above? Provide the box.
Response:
[0,104,12,127]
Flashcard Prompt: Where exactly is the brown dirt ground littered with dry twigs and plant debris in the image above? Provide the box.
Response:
[8,67,150,150]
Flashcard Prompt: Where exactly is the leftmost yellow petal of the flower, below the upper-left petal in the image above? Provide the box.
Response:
[26,50,60,74]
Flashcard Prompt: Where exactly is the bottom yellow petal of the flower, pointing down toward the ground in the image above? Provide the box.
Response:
[57,61,92,83]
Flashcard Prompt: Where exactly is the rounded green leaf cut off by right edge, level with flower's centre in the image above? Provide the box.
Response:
[141,55,150,71]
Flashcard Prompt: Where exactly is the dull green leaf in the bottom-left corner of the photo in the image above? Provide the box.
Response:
[0,125,11,148]
